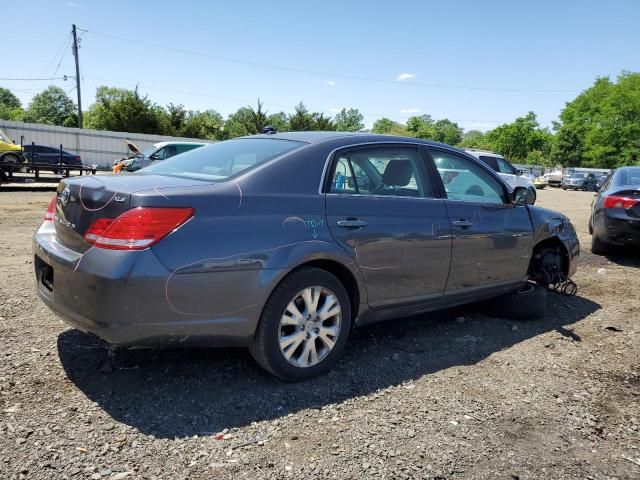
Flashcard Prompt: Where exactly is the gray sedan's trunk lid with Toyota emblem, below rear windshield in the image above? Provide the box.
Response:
[54,175,210,252]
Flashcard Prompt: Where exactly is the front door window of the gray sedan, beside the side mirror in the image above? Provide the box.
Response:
[430,150,506,204]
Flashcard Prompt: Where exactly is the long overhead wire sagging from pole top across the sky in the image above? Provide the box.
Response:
[78,28,573,93]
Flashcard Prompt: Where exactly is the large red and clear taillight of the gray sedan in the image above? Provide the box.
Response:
[84,207,194,250]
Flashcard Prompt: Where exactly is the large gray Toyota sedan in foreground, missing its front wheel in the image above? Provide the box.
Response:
[34,132,579,380]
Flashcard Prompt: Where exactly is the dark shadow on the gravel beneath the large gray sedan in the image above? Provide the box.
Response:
[58,295,600,438]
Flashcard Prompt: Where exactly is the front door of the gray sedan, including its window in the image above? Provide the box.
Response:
[429,148,533,293]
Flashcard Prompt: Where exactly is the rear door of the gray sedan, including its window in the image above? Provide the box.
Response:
[325,145,451,309]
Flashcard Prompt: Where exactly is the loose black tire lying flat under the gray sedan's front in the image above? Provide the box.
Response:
[484,282,547,320]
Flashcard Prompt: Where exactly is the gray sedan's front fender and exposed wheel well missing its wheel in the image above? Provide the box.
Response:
[528,206,580,295]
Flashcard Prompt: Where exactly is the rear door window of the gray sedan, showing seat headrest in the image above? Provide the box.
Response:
[330,148,433,197]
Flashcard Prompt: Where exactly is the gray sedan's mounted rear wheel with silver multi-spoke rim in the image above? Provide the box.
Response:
[249,268,351,381]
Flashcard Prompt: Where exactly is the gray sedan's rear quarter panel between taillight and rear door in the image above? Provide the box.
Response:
[144,144,366,315]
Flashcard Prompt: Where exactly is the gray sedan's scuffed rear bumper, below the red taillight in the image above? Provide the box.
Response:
[33,224,263,346]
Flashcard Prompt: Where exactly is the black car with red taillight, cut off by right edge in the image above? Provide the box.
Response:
[589,167,640,254]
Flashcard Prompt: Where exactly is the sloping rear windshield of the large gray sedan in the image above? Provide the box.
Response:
[140,138,305,180]
